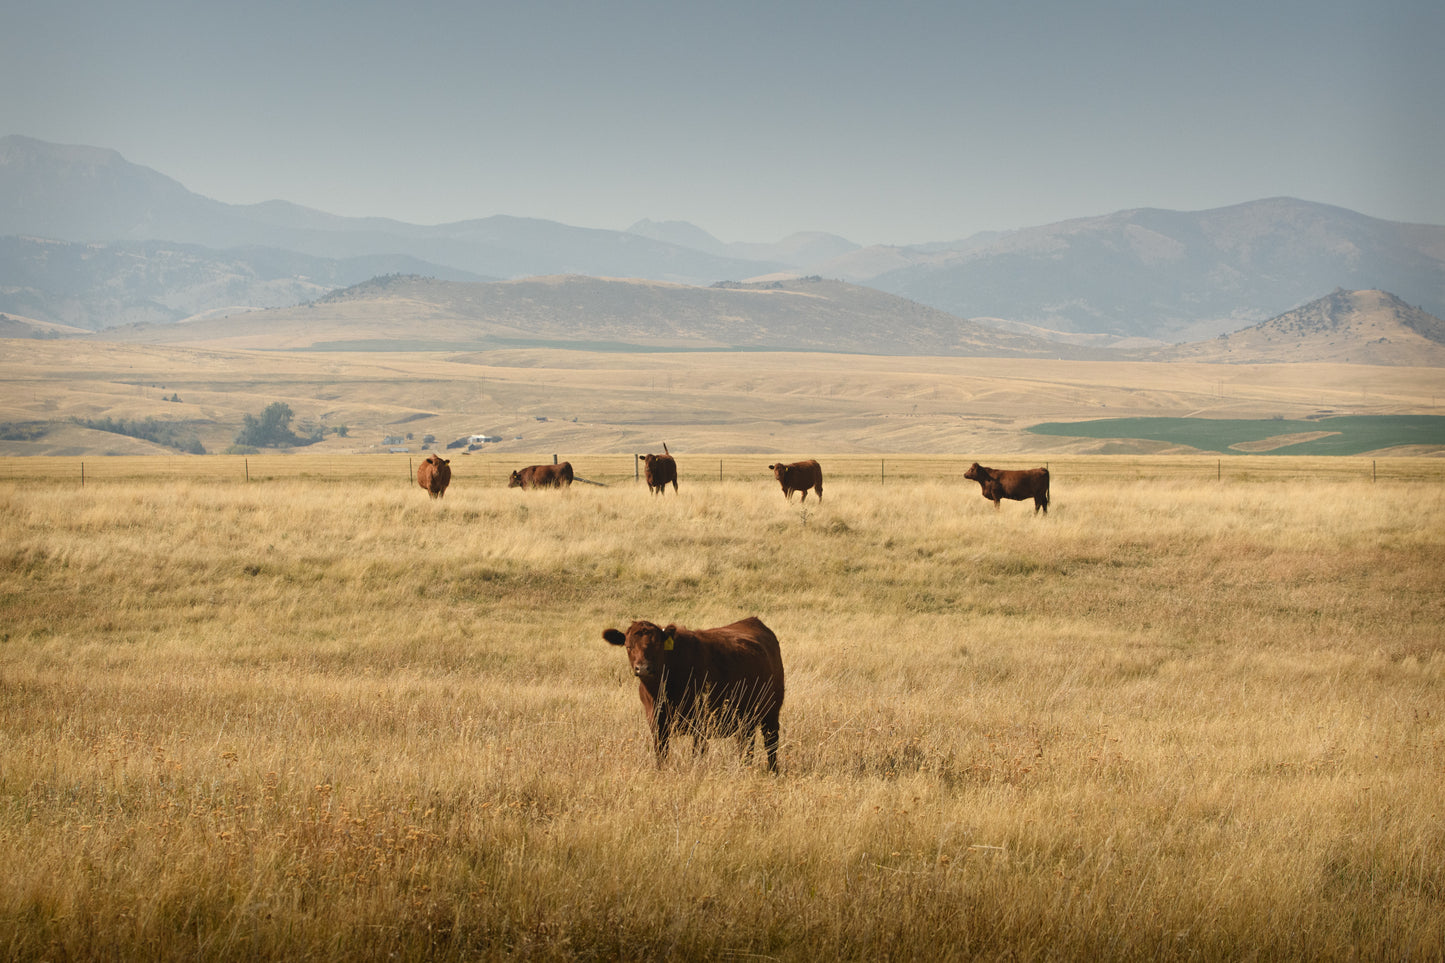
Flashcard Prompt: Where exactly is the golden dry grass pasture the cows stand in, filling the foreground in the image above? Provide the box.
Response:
[0,453,1445,960]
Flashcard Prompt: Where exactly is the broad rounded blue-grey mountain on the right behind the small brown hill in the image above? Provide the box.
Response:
[832,198,1445,341]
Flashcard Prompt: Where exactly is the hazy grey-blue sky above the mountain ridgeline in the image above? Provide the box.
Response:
[0,0,1445,244]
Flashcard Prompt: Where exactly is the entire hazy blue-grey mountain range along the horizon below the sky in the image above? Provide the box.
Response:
[0,136,1445,350]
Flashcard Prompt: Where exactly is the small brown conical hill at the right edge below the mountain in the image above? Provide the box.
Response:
[1142,291,1445,366]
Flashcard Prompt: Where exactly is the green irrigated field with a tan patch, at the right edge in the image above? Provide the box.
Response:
[1029,415,1445,455]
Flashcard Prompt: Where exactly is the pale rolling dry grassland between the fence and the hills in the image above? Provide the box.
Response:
[0,340,1445,464]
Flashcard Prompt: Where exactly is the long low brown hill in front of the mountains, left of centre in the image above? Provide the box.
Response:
[97,276,1097,357]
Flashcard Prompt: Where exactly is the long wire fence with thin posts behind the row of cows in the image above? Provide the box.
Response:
[0,454,1445,487]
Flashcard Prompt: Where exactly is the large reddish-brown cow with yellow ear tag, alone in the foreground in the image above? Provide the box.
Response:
[603,617,783,772]
